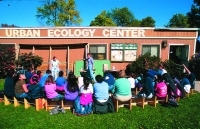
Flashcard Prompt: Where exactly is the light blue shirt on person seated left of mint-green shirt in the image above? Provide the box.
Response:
[93,82,109,100]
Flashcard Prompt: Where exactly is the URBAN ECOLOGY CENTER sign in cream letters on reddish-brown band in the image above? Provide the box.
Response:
[0,28,145,38]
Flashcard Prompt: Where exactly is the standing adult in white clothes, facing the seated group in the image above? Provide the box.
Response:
[51,56,60,80]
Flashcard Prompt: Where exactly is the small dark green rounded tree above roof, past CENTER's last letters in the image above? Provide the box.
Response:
[140,16,155,27]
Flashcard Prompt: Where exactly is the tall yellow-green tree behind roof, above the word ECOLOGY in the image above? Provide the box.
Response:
[36,0,82,26]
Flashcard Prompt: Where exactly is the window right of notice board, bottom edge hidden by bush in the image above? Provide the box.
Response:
[142,45,160,57]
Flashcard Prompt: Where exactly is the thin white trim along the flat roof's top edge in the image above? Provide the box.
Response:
[0,26,199,31]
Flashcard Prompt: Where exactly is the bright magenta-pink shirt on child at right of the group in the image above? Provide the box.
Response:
[155,82,167,98]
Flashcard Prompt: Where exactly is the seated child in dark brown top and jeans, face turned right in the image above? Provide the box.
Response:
[15,74,28,98]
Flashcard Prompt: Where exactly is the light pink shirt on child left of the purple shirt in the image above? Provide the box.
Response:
[44,83,58,99]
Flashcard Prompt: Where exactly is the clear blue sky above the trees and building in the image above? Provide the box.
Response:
[0,0,193,27]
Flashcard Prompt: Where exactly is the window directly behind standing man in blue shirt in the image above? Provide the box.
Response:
[90,44,107,60]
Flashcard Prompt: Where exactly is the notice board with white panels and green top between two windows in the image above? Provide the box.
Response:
[110,43,137,61]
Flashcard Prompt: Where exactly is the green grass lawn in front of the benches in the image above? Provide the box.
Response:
[0,79,200,129]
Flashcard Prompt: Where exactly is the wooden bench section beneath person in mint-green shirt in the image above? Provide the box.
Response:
[113,97,132,112]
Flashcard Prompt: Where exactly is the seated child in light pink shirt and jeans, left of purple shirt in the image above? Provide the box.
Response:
[44,75,63,101]
